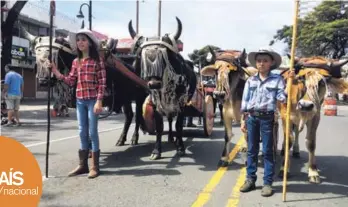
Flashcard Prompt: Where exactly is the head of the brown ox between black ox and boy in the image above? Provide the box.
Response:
[201,47,247,101]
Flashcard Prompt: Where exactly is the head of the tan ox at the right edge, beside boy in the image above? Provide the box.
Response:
[282,57,348,122]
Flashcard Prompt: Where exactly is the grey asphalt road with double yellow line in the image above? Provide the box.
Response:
[1,102,348,207]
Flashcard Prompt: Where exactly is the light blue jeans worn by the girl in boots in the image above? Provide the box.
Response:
[76,99,99,152]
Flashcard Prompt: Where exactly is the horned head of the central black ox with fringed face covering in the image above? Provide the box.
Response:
[128,17,184,90]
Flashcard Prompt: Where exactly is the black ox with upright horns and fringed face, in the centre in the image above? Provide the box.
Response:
[128,18,197,160]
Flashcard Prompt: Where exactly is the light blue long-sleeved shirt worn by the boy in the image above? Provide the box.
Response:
[241,73,287,112]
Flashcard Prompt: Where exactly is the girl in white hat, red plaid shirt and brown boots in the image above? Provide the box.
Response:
[51,29,106,178]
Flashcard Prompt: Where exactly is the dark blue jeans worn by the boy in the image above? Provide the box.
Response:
[247,115,274,185]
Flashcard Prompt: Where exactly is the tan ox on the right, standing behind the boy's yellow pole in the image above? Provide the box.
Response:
[278,57,348,183]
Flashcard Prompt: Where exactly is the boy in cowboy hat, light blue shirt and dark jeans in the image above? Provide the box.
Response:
[240,49,294,197]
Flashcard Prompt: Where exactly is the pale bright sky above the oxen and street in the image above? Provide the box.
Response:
[18,0,312,58]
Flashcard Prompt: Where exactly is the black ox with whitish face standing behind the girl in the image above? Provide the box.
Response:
[20,23,147,146]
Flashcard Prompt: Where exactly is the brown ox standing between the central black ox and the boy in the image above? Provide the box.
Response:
[201,48,255,166]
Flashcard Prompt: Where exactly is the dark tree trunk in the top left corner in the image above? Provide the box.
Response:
[1,1,28,80]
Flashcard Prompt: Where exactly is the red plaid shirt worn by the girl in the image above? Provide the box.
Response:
[59,58,106,100]
